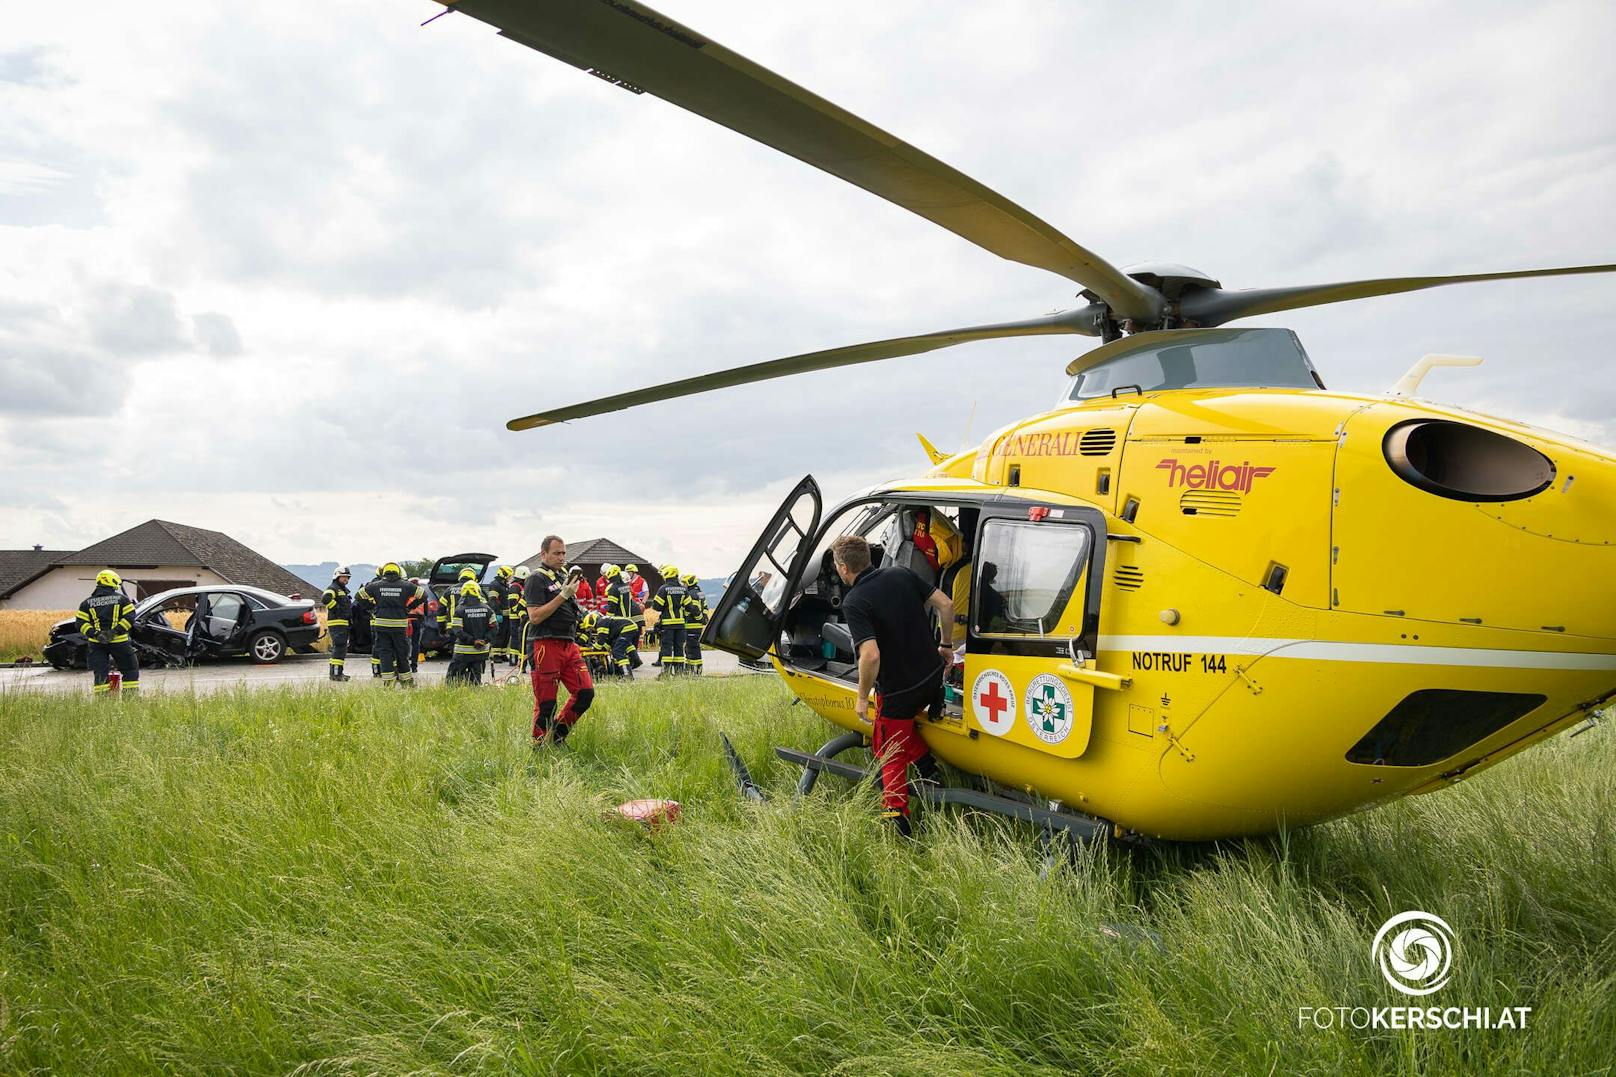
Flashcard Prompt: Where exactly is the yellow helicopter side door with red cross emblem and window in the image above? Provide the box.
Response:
[962,501,1105,758]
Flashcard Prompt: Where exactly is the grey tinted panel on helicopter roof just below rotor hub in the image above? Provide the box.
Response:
[1067,328,1324,399]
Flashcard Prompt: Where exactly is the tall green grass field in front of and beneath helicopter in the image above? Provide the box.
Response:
[0,678,1616,1077]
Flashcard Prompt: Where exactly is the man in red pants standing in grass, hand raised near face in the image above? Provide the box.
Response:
[527,535,595,747]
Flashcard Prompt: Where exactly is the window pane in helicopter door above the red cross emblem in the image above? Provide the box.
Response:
[971,519,1091,637]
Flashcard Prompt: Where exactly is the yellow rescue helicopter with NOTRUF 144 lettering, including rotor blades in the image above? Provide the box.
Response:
[426,0,1616,839]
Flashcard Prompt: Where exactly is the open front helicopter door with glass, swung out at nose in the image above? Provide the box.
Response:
[701,475,821,661]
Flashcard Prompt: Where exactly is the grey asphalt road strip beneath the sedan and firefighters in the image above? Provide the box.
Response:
[0,650,751,695]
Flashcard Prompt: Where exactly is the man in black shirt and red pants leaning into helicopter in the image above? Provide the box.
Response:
[831,535,953,838]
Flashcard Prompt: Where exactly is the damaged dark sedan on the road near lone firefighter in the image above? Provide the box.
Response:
[44,584,322,669]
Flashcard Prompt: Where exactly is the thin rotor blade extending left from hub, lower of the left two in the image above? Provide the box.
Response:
[506,306,1104,430]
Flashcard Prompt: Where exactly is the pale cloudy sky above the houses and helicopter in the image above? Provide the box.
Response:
[0,0,1616,576]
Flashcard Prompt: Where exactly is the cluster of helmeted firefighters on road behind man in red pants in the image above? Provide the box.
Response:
[320,561,708,684]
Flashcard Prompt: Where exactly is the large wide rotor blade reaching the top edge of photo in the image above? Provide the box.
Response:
[438,0,1164,320]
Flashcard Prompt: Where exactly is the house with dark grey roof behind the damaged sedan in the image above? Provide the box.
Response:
[0,519,318,610]
